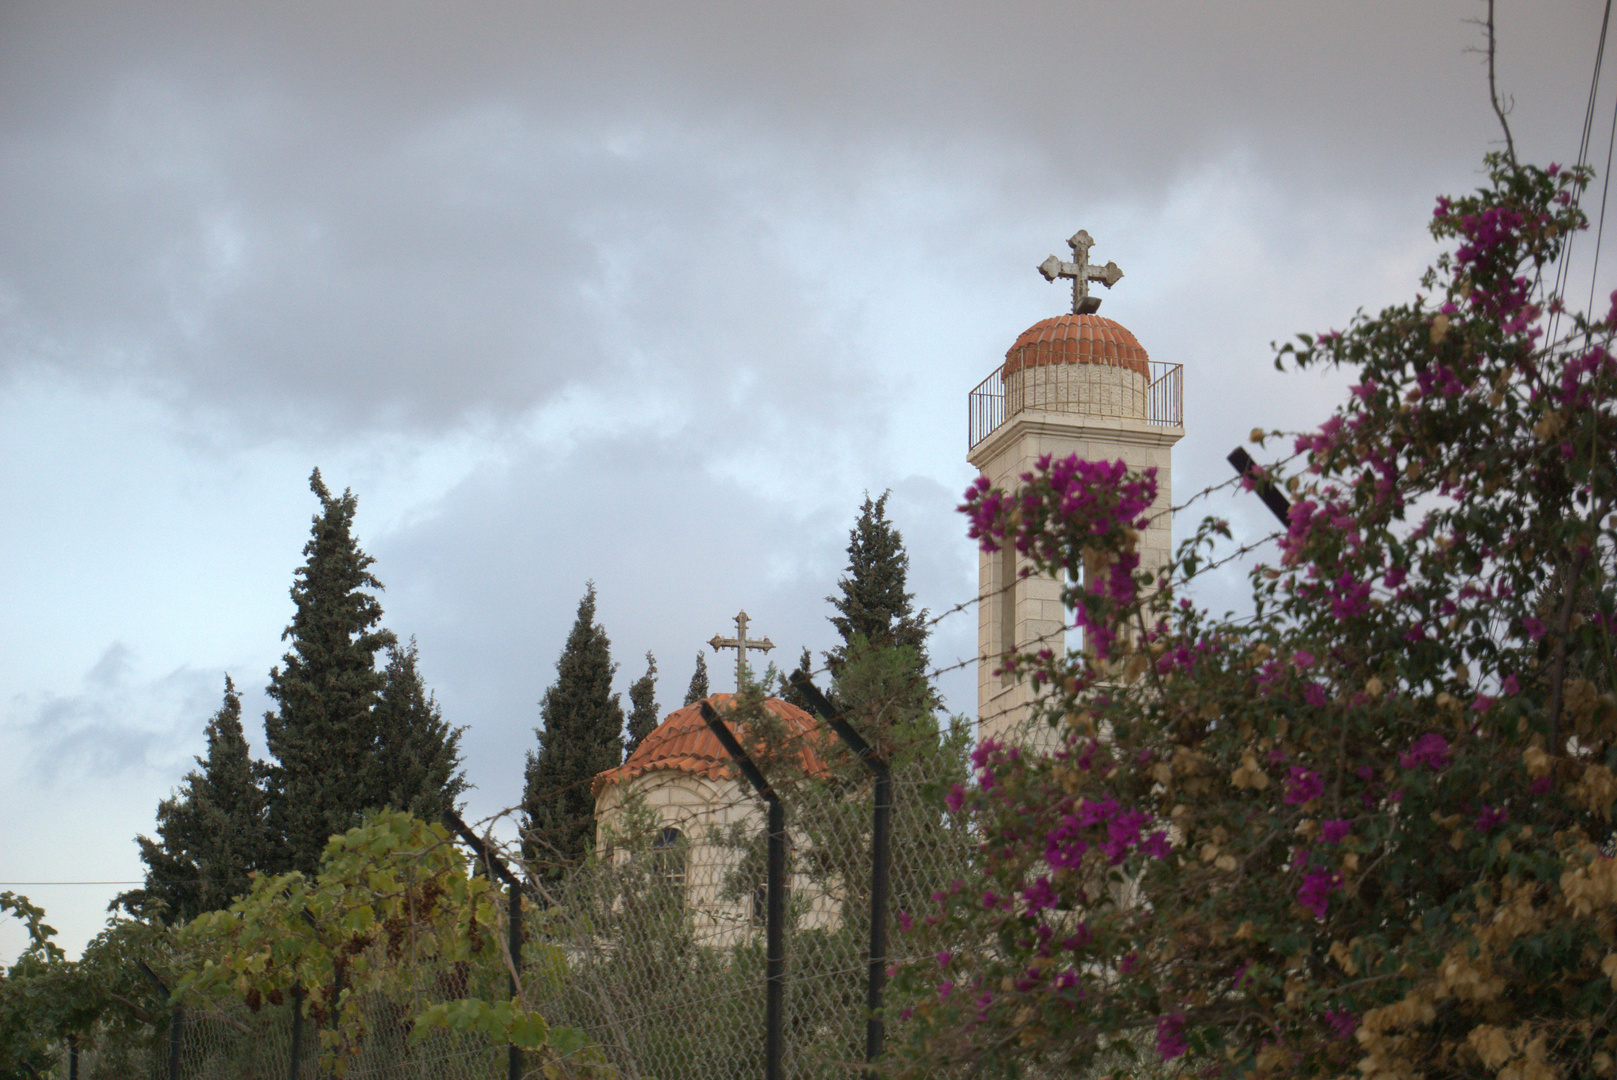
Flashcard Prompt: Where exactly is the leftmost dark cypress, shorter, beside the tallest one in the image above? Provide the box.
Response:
[115,676,272,923]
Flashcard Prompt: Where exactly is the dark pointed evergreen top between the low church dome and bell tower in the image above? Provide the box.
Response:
[825,491,930,704]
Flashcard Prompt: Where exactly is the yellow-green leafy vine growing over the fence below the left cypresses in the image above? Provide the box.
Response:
[176,810,607,1077]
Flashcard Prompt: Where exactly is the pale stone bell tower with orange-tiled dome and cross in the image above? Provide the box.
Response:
[967,231,1185,739]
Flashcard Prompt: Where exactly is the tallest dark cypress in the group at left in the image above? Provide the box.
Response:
[264,469,396,875]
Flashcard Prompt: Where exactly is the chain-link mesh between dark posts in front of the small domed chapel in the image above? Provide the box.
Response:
[529,708,975,1080]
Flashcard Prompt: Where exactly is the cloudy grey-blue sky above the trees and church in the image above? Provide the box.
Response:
[0,0,1617,959]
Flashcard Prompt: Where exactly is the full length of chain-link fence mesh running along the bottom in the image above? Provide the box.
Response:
[41,704,975,1080]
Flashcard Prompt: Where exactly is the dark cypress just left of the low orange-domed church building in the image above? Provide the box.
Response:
[522,582,623,873]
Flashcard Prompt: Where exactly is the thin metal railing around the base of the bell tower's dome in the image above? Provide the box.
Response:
[967,361,1185,448]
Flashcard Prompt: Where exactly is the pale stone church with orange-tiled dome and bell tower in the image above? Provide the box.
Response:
[593,230,1184,930]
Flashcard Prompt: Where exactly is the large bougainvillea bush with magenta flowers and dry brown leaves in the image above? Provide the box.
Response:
[894,157,1617,1080]
